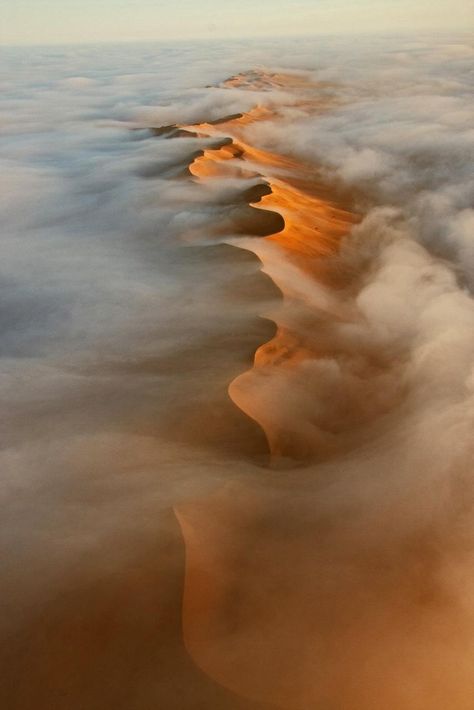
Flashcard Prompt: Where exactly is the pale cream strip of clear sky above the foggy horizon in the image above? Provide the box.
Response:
[0,0,474,45]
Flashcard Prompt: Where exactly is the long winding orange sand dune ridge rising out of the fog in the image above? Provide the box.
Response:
[165,73,473,710]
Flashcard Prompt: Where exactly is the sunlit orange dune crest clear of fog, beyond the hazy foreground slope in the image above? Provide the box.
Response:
[179,72,359,464]
